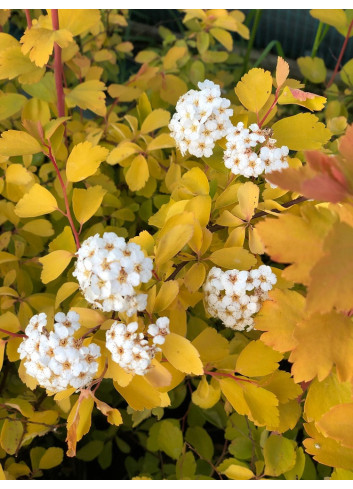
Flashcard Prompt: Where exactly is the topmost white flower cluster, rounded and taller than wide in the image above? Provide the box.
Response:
[169,80,233,158]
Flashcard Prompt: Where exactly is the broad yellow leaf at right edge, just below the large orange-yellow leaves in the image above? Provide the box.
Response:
[304,371,353,422]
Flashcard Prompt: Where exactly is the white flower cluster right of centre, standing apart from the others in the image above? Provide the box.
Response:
[204,265,277,331]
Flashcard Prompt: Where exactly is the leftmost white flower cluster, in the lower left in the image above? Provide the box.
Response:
[18,311,101,392]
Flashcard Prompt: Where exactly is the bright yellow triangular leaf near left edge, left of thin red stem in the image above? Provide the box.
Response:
[15,183,58,217]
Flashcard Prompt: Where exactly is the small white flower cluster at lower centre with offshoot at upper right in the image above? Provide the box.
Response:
[106,317,169,375]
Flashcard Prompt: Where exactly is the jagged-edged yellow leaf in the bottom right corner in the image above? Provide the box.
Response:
[303,423,353,470]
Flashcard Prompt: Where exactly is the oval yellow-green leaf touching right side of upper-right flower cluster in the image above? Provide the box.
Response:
[272,113,331,151]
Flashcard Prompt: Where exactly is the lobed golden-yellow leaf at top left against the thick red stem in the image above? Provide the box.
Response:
[20,23,73,67]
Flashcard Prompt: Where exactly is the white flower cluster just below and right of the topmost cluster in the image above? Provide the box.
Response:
[224,122,289,178]
